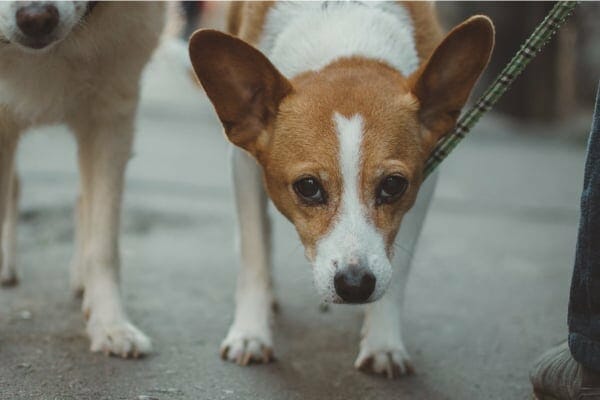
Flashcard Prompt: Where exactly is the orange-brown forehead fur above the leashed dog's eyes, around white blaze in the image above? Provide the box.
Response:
[271,60,420,172]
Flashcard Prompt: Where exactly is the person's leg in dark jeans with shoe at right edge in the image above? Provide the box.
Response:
[530,82,600,400]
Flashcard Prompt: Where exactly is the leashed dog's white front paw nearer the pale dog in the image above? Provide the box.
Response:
[221,327,273,365]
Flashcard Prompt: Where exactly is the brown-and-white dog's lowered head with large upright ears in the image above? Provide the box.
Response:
[190,16,494,303]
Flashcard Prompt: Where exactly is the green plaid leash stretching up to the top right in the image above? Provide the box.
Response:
[423,1,578,179]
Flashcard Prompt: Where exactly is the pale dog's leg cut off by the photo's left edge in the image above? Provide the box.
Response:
[0,112,19,286]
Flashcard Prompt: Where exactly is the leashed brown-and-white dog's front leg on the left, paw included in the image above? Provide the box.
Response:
[221,148,273,365]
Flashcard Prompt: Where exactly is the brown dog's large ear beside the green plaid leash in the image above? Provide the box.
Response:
[410,15,494,148]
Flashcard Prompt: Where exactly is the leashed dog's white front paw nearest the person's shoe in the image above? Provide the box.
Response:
[354,349,414,379]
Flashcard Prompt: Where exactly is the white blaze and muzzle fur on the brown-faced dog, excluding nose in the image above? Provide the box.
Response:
[314,113,391,300]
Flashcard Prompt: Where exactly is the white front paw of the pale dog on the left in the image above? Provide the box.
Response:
[87,318,152,358]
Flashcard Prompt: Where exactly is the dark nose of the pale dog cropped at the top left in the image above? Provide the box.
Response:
[16,4,59,39]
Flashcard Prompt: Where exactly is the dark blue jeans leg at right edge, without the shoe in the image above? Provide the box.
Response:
[569,86,600,373]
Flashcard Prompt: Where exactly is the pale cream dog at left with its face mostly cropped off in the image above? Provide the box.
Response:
[0,1,164,357]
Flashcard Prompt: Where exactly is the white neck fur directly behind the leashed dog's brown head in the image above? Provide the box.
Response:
[259,1,419,78]
